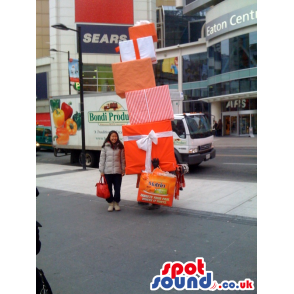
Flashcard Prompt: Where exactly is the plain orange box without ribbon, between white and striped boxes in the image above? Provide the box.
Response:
[112,58,156,98]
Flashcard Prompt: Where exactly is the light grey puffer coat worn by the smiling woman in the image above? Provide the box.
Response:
[99,142,126,174]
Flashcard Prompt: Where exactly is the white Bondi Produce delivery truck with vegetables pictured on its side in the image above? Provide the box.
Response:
[50,93,215,167]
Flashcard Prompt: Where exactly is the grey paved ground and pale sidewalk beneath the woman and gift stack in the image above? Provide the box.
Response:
[36,137,257,293]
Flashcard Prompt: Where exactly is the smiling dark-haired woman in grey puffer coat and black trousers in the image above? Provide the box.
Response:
[99,131,126,211]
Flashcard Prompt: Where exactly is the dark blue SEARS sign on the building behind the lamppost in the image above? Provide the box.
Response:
[78,24,129,54]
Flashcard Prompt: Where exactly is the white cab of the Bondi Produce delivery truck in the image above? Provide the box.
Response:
[172,113,216,165]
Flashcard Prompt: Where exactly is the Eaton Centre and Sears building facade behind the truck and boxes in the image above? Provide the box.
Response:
[36,0,257,136]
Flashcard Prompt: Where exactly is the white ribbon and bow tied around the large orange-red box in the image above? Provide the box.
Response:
[123,130,173,173]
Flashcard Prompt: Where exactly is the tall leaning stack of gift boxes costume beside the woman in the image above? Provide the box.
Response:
[112,21,184,206]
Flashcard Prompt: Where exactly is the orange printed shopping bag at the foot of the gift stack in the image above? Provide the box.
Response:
[137,173,177,207]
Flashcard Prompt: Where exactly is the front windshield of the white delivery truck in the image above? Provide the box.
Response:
[185,115,212,139]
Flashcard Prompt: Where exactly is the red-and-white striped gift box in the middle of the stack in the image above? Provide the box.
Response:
[126,85,174,125]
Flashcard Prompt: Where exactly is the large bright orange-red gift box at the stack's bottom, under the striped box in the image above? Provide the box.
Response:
[122,120,177,175]
